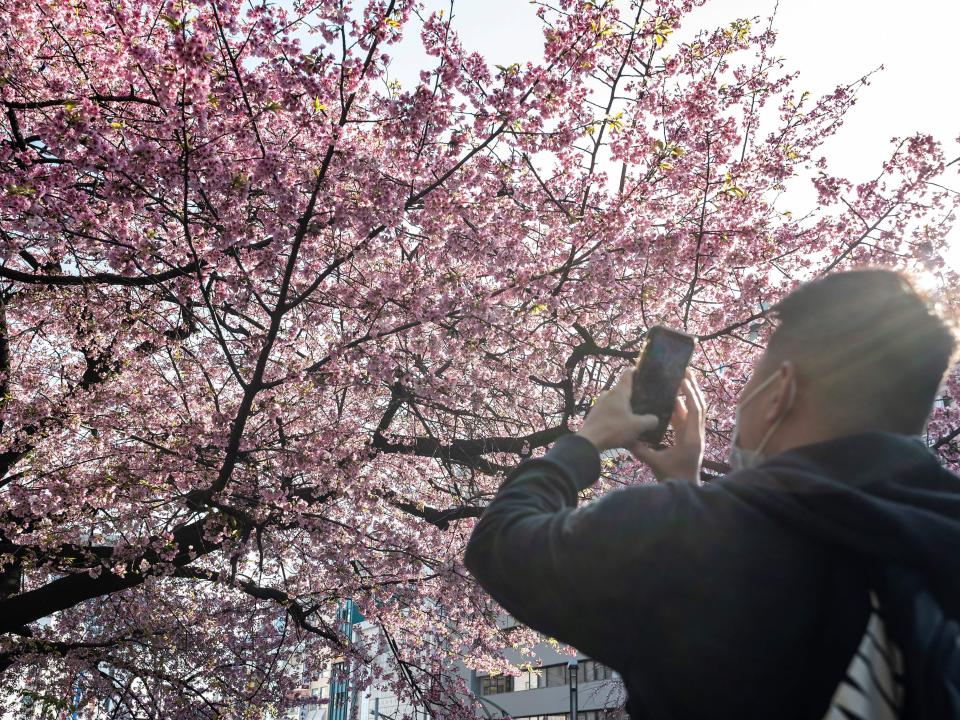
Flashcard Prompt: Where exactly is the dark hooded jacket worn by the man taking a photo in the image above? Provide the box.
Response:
[464,433,960,720]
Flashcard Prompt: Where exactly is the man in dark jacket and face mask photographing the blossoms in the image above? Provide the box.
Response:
[464,269,960,720]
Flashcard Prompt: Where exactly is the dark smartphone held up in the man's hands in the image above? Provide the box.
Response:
[630,325,694,445]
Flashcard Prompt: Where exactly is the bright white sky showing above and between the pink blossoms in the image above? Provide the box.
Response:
[382,0,960,269]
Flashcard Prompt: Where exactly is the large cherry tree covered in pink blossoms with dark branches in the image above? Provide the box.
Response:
[0,0,960,718]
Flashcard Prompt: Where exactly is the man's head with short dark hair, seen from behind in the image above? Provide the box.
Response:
[737,269,956,455]
